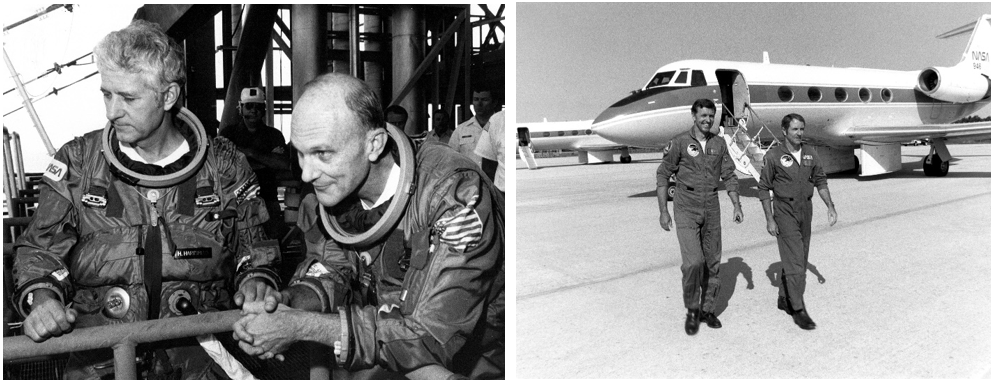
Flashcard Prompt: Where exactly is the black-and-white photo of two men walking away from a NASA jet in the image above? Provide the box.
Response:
[515,3,991,379]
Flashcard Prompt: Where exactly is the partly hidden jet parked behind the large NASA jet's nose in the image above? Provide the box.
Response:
[516,120,633,168]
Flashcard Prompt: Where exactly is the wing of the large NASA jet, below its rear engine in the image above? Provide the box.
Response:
[844,122,991,143]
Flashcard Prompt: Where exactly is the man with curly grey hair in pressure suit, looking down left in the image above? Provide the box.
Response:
[12,21,279,379]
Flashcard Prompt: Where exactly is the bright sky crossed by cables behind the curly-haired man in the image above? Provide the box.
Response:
[0,1,140,172]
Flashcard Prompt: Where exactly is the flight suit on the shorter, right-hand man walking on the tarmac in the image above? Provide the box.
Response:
[757,145,828,311]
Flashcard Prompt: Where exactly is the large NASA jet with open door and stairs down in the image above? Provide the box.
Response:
[592,15,991,179]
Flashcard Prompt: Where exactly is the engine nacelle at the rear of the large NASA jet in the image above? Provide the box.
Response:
[919,67,991,103]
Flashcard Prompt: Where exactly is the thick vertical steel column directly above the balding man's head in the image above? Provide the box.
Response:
[292,4,327,103]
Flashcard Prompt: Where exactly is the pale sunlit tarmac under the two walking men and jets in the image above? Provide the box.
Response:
[516,144,991,378]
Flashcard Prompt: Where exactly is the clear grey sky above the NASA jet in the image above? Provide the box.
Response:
[516,2,991,122]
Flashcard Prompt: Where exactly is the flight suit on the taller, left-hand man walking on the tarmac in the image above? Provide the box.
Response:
[657,126,738,312]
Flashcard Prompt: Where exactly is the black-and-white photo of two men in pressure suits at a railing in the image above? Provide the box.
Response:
[3,3,511,380]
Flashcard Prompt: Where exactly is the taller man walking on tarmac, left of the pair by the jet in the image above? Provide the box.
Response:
[657,99,743,335]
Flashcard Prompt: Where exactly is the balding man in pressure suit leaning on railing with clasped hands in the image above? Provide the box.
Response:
[234,74,505,378]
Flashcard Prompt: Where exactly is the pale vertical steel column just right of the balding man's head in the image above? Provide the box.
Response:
[392,5,426,135]
